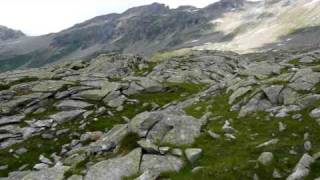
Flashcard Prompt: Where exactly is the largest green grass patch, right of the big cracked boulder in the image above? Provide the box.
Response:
[162,94,320,180]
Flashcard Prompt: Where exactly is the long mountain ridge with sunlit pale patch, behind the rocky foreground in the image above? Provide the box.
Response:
[0,0,320,71]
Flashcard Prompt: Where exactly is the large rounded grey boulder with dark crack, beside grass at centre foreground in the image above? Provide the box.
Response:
[129,111,202,145]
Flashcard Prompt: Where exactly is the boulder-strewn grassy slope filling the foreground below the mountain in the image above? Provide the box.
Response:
[0,47,320,180]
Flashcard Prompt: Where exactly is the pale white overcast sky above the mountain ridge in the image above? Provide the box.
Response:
[0,0,217,35]
